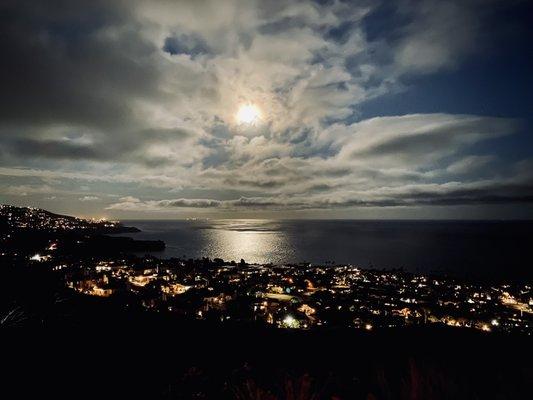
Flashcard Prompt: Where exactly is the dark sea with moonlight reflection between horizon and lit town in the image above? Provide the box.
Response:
[123,219,533,280]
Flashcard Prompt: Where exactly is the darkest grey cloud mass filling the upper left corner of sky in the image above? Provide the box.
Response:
[0,1,158,127]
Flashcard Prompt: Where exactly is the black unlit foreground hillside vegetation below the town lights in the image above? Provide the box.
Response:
[2,319,533,400]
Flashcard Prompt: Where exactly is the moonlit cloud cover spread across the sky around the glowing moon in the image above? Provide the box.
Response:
[0,0,533,216]
